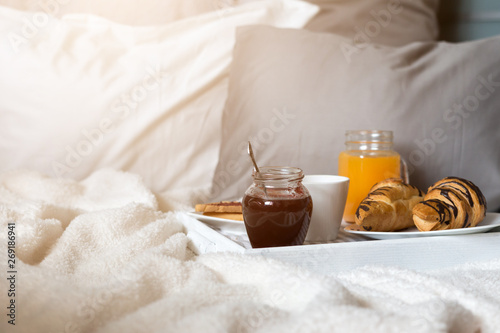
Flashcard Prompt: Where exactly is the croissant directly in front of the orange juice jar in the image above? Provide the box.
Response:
[355,178,424,231]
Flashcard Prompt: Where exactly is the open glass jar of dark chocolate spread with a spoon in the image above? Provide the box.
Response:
[242,167,313,248]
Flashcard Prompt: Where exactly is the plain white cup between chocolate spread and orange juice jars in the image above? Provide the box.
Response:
[302,175,349,243]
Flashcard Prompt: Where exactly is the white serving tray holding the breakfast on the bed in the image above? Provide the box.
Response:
[184,214,500,274]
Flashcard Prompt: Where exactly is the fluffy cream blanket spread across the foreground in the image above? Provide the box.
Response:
[0,170,500,333]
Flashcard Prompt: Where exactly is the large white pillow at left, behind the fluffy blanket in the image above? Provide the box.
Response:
[0,0,317,197]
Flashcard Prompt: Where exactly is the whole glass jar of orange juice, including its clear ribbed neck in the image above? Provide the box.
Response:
[338,130,401,223]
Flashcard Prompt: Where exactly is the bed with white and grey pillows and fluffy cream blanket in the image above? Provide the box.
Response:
[0,0,500,332]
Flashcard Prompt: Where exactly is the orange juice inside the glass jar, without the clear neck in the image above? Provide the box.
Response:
[338,150,400,222]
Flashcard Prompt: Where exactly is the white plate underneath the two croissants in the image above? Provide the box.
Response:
[344,213,500,239]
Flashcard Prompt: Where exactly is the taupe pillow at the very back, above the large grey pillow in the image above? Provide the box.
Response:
[237,0,439,45]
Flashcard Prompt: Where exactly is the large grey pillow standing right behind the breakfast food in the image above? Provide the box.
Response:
[213,27,500,210]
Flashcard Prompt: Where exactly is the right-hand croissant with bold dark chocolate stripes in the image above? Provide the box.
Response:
[413,177,487,231]
